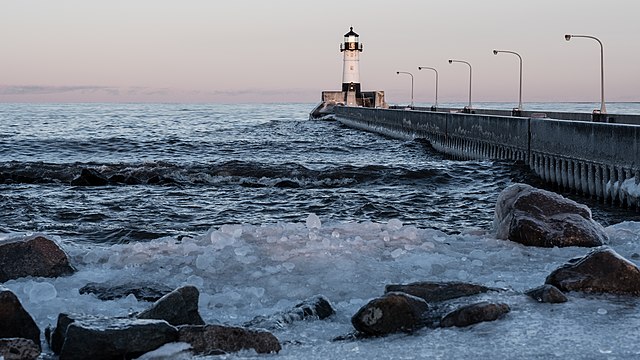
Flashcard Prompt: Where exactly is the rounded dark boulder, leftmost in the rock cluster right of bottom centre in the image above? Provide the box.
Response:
[351,292,429,336]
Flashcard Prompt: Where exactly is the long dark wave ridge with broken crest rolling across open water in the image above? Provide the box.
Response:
[0,160,452,188]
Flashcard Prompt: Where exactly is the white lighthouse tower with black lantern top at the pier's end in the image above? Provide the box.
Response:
[340,27,362,106]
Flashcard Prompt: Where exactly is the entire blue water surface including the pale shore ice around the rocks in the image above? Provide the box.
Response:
[0,103,640,359]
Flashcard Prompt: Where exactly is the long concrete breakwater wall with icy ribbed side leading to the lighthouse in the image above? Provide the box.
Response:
[335,107,640,207]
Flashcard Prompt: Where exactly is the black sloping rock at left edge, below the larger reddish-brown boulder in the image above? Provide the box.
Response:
[0,289,40,349]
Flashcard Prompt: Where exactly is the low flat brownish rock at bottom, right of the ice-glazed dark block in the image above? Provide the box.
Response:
[178,325,282,355]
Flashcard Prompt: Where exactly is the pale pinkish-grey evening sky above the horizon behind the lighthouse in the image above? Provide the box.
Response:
[0,0,640,104]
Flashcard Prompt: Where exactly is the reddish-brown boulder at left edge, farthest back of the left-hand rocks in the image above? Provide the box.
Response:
[0,236,75,282]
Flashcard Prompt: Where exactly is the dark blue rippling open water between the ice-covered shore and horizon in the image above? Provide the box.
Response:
[0,100,636,243]
